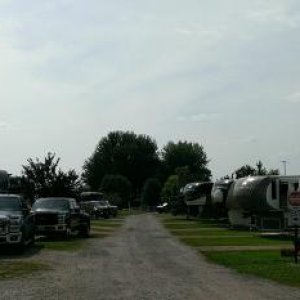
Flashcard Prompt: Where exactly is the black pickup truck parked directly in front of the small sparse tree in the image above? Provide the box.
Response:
[32,197,90,238]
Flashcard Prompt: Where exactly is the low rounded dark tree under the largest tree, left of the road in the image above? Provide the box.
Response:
[100,175,131,207]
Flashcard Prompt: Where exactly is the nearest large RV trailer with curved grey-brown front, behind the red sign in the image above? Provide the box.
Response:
[226,175,300,230]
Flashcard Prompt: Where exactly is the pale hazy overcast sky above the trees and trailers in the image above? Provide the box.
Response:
[0,0,300,178]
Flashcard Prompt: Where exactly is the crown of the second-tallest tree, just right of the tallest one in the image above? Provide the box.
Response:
[162,141,211,181]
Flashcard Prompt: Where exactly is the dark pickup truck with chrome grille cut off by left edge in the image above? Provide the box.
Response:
[0,194,35,249]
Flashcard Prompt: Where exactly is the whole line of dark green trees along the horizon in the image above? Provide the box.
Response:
[10,131,279,207]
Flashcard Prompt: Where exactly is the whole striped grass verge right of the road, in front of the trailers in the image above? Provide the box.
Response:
[159,216,300,287]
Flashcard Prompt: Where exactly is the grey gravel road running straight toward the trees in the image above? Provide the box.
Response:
[0,214,300,300]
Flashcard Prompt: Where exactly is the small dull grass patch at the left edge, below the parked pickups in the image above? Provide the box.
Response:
[0,261,51,280]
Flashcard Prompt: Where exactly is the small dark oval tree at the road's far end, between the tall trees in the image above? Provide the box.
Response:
[142,178,161,206]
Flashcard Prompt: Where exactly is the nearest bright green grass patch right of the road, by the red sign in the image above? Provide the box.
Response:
[205,251,300,287]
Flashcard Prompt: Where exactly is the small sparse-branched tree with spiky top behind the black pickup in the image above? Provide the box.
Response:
[22,152,80,200]
